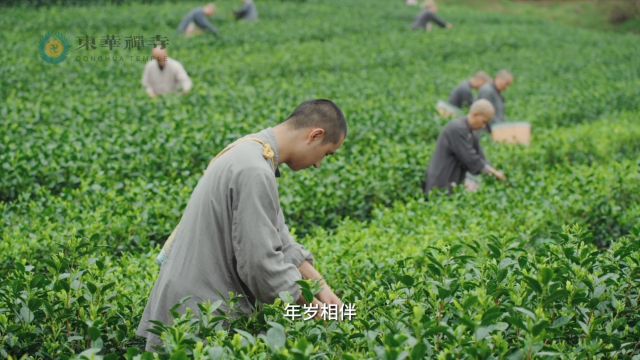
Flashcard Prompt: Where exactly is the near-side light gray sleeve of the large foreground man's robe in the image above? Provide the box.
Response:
[231,169,302,303]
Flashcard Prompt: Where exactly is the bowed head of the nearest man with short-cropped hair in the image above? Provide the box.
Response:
[274,99,347,171]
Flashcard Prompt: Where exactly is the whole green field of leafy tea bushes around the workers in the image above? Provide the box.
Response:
[0,0,640,359]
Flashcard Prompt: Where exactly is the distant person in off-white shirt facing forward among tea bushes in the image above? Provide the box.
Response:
[142,48,192,98]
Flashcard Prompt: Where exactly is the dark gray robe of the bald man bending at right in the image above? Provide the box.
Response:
[423,117,488,195]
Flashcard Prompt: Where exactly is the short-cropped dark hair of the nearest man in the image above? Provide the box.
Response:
[285,99,347,144]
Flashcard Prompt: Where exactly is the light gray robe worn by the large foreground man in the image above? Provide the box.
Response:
[137,128,313,350]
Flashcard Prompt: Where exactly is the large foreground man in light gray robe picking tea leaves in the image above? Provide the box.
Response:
[136,99,347,351]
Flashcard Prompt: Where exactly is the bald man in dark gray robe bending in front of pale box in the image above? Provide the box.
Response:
[423,100,506,196]
